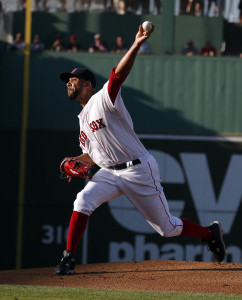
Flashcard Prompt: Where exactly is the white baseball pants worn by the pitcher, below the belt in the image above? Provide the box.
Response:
[74,153,183,237]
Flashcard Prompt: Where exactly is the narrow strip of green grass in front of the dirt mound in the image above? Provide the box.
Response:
[0,285,242,300]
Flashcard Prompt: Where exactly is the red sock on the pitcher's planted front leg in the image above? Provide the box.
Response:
[66,211,88,253]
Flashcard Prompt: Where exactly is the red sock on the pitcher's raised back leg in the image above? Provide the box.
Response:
[181,218,212,240]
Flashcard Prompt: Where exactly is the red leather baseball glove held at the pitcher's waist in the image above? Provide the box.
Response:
[60,157,96,182]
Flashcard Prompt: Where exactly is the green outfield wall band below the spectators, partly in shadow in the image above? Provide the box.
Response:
[0,52,242,134]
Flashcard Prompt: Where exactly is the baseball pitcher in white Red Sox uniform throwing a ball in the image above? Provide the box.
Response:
[55,24,225,275]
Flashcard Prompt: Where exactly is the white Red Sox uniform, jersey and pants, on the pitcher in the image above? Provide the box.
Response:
[74,70,183,236]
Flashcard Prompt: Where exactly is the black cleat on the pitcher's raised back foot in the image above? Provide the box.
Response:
[202,221,226,263]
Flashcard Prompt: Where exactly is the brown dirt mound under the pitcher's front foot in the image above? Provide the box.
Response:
[0,261,242,294]
